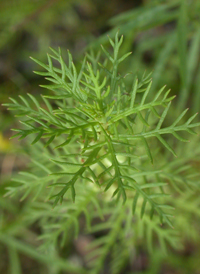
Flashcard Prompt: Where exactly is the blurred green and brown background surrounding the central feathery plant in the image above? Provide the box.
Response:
[0,0,200,274]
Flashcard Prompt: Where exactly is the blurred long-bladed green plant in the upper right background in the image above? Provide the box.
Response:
[93,0,200,112]
